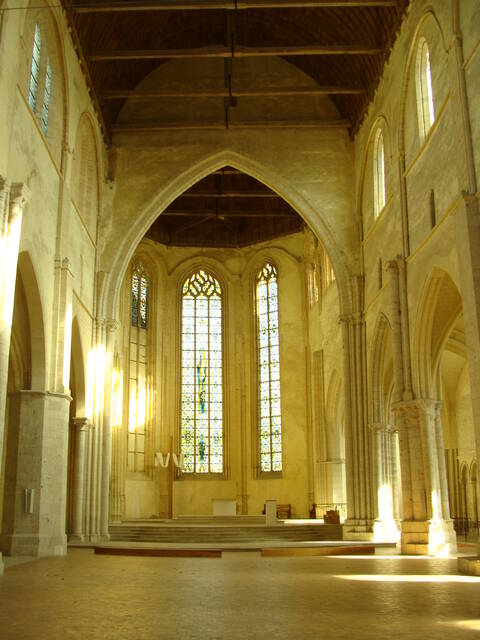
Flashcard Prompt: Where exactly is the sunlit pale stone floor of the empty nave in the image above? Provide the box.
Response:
[0,549,480,640]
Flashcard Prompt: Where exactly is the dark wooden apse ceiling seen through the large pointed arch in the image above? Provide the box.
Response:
[146,167,304,247]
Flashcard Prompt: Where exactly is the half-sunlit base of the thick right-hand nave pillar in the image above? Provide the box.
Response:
[400,520,457,556]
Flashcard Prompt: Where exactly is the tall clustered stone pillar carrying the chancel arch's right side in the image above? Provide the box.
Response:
[340,278,374,540]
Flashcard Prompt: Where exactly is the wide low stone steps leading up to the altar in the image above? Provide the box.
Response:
[110,522,342,545]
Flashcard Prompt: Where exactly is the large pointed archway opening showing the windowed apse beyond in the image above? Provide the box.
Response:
[112,165,346,520]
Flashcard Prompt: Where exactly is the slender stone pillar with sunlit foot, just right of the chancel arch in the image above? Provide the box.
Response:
[369,422,400,542]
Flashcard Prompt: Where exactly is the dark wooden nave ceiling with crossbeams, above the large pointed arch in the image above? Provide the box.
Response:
[62,0,408,140]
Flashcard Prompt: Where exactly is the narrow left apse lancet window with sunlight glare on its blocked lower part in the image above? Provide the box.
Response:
[128,264,150,471]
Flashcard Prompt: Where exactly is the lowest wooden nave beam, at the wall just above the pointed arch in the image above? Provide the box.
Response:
[111,120,352,133]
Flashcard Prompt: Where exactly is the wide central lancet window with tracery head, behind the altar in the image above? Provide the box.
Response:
[181,269,223,474]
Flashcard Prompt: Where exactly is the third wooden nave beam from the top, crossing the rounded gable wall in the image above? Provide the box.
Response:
[102,86,365,101]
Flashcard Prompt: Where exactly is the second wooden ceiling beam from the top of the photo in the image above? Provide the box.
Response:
[89,44,382,62]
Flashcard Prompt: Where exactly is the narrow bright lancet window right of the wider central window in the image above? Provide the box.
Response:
[256,262,282,473]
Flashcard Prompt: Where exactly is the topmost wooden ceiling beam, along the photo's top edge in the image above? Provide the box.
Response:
[73,0,397,13]
